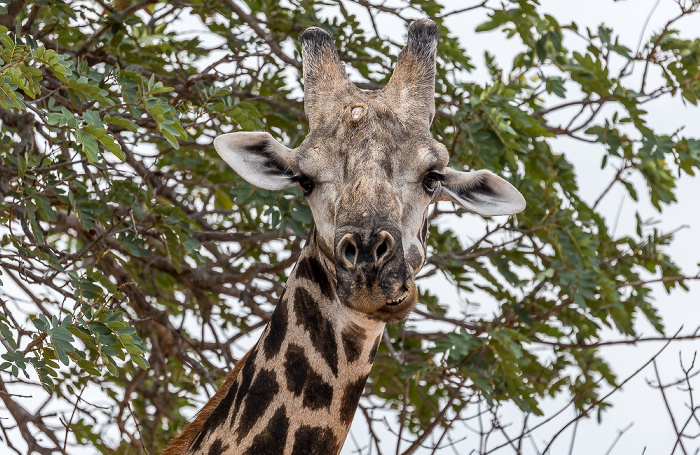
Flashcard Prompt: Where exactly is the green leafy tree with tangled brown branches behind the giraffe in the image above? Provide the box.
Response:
[0,0,700,454]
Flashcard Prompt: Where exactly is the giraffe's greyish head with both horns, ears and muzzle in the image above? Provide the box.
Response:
[214,19,525,322]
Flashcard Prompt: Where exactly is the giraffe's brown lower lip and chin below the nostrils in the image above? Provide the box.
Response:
[341,280,418,324]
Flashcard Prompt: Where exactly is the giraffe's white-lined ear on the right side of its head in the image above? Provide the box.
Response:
[440,168,525,216]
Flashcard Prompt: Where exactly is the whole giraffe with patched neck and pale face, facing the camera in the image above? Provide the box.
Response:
[163,19,525,455]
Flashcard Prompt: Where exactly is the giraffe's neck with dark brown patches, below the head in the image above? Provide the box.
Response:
[186,235,384,455]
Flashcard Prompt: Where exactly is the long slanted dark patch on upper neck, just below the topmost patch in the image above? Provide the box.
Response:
[294,288,338,377]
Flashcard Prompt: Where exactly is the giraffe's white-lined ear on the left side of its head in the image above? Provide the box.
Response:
[214,132,294,190]
